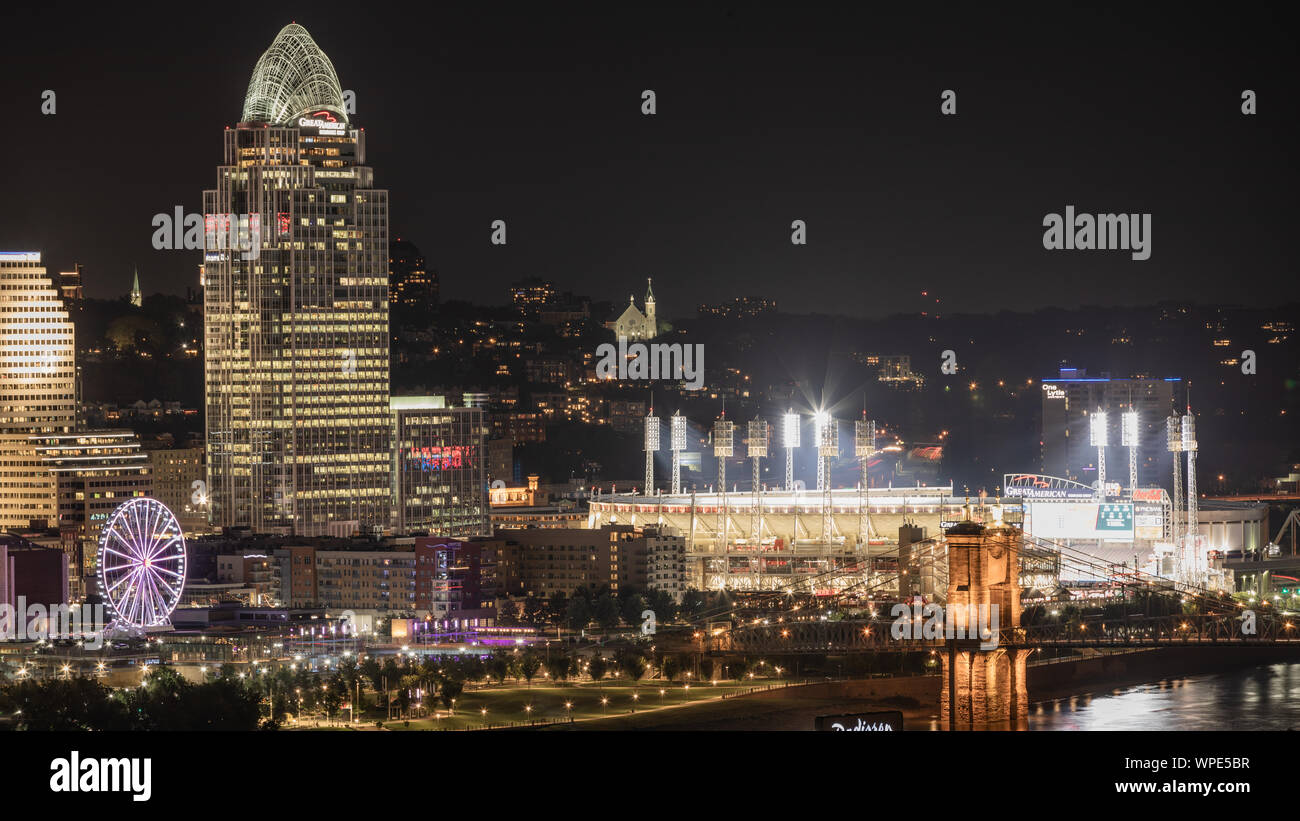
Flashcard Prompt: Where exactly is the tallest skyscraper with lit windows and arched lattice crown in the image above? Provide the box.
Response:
[203,25,391,535]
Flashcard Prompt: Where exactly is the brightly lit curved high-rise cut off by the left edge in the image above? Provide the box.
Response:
[0,252,77,530]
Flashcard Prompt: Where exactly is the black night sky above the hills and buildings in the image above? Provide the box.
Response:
[0,3,1300,318]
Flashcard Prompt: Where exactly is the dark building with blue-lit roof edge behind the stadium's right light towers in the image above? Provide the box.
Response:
[1043,368,1178,487]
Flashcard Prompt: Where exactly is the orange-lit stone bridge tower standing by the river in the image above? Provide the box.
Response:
[939,520,1032,730]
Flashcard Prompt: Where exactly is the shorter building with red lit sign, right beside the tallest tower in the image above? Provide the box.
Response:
[391,396,491,538]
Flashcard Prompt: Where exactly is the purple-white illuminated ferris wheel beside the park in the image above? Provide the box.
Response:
[99,498,185,630]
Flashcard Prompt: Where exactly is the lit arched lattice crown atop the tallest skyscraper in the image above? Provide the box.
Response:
[241,23,347,125]
